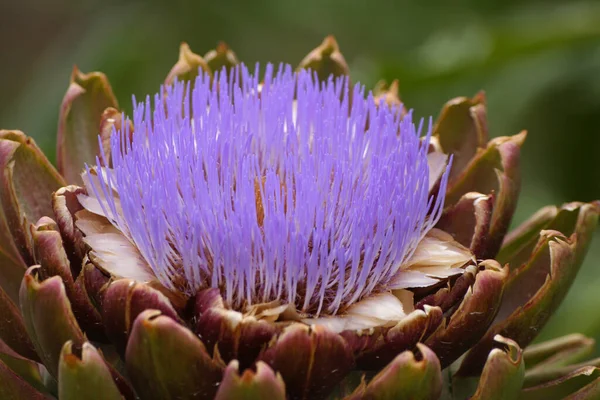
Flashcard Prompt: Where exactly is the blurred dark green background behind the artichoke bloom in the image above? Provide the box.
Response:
[0,0,600,339]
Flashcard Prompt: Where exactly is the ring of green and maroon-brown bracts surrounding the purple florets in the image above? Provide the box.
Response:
[0,37,600,400]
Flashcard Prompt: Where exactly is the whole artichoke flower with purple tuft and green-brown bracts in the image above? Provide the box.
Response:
[0,37,600,400]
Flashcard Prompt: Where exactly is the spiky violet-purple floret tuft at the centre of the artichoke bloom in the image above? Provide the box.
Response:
[87,66,447,315]
